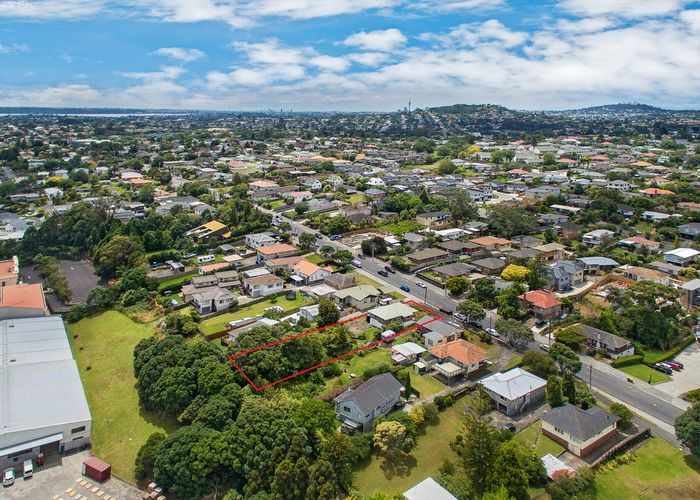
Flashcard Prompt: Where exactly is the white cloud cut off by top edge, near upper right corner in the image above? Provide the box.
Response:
[559,0,690,19]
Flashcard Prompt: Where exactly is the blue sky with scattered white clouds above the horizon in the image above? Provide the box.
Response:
[0,0,700,111]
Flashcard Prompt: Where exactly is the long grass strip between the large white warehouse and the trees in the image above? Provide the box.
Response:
[68,311,175,482]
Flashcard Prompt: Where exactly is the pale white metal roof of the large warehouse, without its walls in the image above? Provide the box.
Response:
[0,316,91,448]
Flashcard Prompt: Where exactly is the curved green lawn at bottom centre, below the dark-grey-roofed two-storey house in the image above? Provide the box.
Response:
[353,399,464,495]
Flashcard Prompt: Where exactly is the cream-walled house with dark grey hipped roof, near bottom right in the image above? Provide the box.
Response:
[542,403,620,457]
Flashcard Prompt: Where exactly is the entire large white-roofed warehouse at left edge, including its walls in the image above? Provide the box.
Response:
[0,316,92,469]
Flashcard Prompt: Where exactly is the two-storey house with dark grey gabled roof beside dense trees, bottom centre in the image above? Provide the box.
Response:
[333,373,403,432]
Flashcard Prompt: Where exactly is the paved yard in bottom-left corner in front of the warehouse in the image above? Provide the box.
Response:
[0,450,142,500]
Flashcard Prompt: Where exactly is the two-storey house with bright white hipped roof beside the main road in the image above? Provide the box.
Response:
[479,368,547,416]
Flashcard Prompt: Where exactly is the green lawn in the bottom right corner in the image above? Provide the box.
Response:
[596,438,700,499]
